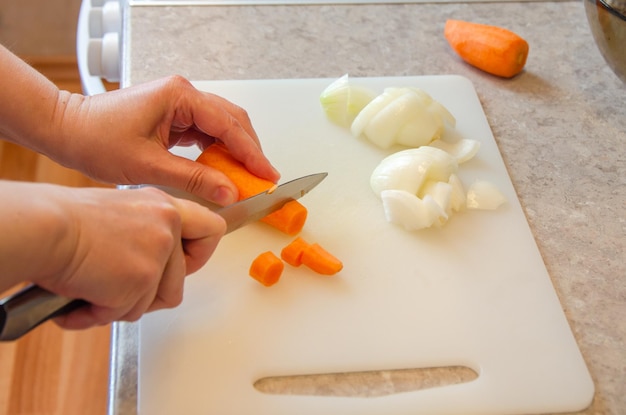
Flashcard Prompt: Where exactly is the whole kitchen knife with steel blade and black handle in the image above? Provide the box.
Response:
[0,173,328,341]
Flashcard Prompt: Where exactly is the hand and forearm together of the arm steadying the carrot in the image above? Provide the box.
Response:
[0,46,279,205]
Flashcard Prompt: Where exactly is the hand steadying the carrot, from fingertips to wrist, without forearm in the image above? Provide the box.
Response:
[55,76,279,205]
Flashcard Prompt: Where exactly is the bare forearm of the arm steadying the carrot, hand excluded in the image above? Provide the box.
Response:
[0,45,83,161]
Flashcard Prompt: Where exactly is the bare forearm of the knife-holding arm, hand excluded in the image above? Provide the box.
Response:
[0,180,69,292]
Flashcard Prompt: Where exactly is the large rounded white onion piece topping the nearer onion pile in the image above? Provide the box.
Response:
[370,146,458,197]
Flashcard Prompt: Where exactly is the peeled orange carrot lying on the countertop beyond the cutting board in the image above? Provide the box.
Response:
[444,20,528,78]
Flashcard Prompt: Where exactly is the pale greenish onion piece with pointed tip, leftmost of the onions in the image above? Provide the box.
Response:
[320,74,376,127]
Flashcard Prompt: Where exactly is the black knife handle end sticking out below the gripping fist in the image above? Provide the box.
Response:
[0,285,87,341]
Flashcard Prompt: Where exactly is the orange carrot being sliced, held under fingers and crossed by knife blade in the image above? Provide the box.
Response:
[196,144,308,235]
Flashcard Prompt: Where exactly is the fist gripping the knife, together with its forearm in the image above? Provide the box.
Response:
[0,181,226,329]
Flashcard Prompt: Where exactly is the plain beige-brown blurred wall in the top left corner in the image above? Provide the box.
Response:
[0,0,81,56]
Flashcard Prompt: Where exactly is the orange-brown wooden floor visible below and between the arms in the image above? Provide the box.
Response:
[0,57,115,415]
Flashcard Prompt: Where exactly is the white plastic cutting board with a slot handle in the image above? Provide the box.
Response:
[139,76,594,415]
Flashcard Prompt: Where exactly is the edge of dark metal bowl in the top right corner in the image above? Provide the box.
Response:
[584,0,626,83]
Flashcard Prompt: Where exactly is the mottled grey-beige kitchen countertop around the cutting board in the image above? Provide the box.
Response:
[109,1,626,415]
